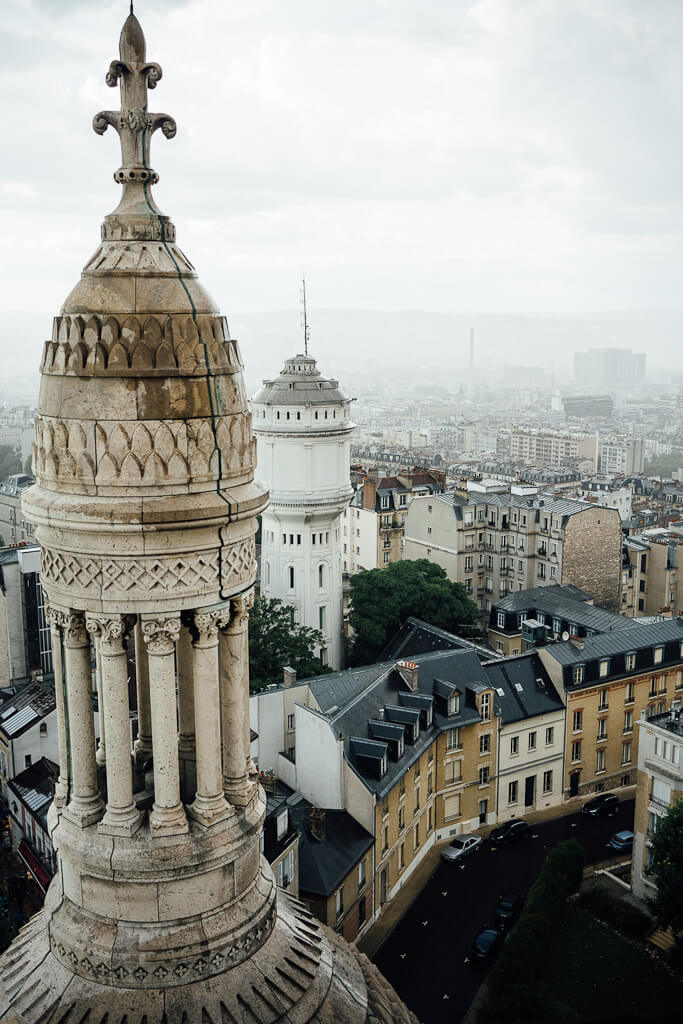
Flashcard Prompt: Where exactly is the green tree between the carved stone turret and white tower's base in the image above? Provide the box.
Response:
[249,596,331,690]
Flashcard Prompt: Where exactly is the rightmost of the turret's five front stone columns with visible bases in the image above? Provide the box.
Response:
[218,595,250,807]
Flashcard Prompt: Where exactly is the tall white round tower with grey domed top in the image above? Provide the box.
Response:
[251,354,354,669]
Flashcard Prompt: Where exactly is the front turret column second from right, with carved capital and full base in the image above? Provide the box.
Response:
[187,609,230,826]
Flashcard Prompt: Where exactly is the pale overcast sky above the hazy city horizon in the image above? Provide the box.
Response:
[0,0,683,314]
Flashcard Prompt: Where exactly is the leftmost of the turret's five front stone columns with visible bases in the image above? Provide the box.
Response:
[63,611,104,828]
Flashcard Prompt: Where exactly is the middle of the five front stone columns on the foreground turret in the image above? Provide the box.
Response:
[142,615,188,836]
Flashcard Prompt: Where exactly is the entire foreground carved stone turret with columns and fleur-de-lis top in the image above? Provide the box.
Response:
[0,13,414,1024]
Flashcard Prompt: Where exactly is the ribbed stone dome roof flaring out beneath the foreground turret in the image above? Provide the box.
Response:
[0,890,418,1024]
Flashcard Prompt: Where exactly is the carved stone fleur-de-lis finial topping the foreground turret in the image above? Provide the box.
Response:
[92,11,176,186]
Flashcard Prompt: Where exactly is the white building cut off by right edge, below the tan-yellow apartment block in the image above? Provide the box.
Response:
[631,700,683,899]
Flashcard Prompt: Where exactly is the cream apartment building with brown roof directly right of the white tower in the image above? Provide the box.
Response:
[342,469,445,572]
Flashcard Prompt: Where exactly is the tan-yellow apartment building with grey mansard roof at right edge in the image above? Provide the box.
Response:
[538,618,683,798]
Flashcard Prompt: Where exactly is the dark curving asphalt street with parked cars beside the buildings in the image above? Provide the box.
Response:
[375,801,634,1024]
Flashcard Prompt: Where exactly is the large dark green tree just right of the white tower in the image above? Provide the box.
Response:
[349,558,479,665]
